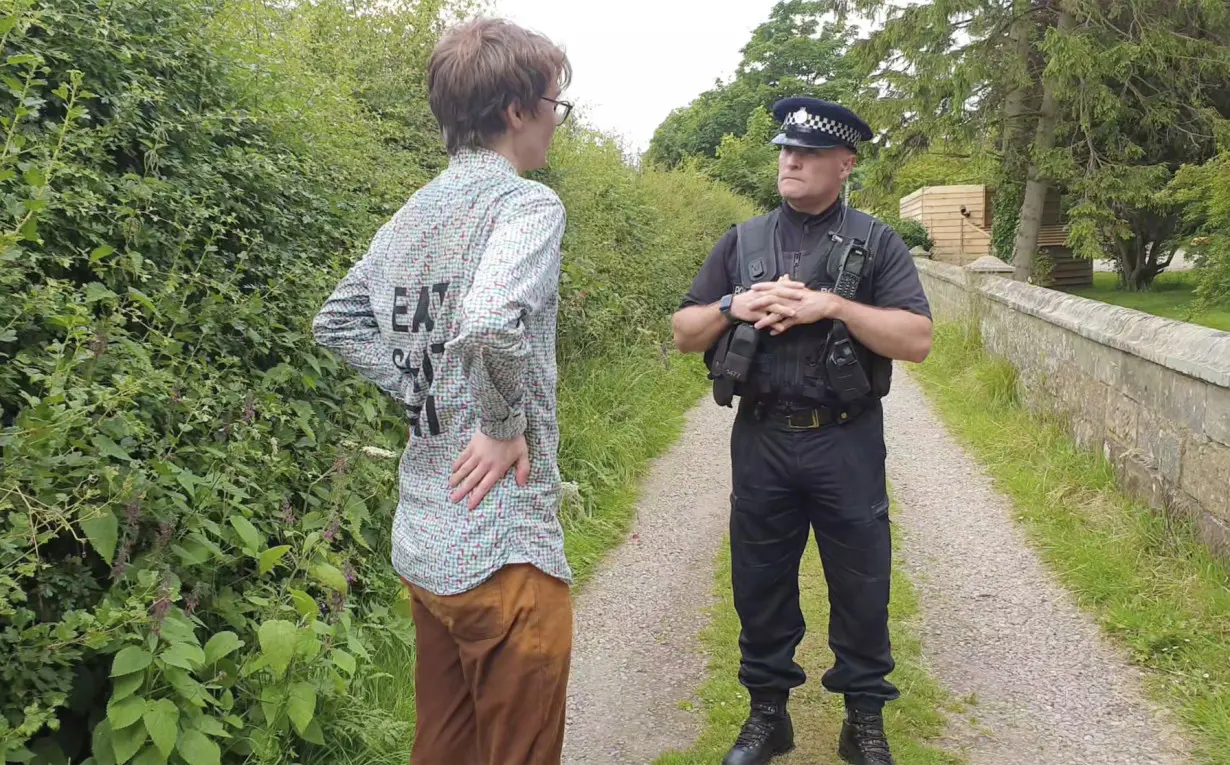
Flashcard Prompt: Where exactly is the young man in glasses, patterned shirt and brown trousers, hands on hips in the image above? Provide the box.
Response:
[314,20,572,765]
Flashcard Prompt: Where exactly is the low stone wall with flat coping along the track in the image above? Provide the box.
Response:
[915,257,1230,555]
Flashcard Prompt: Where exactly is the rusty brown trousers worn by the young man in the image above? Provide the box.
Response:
[407,563,572,765]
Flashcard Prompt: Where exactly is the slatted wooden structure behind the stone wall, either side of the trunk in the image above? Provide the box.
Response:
[898,184,1093,289]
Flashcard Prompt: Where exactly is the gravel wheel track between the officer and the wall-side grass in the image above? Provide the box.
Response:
[884,369,1187,765]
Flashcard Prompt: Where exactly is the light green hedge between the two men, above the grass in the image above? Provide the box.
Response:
[535,123,755,363]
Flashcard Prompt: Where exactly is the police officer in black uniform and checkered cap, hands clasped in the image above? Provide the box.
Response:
[673,97,931,765]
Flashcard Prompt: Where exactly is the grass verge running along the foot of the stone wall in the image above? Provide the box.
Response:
[915,325,1230,765]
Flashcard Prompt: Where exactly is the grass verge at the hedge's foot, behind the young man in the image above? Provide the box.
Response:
[314,348,706,765]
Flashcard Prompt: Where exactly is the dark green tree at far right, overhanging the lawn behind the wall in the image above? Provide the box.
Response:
[1044,0,1230,289]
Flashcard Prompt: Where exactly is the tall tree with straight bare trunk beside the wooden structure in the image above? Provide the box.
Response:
[834,0,1039,242]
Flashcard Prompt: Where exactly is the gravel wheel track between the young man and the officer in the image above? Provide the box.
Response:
[563,398,733,765]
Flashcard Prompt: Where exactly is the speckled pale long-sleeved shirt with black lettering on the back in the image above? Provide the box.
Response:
[312,150,572,595]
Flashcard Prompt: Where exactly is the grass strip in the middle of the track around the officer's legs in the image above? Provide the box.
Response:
[654,526,964,765]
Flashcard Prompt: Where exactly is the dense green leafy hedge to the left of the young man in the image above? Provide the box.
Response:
[0,0,408,765]
